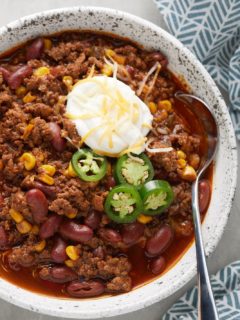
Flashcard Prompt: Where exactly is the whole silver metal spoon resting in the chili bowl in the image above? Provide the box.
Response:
[175,92,219,320]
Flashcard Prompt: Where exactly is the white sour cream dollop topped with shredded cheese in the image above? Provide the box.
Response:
[66,76,153,157]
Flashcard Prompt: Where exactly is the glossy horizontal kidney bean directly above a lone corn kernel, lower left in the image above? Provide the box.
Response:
[59,221,93,242]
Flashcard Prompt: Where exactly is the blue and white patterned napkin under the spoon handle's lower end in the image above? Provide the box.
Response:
[162,260,240,320]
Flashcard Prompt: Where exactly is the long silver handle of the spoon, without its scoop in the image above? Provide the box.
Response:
[192,178,219,320]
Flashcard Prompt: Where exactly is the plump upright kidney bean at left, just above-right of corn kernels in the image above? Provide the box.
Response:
[26,189,48,223]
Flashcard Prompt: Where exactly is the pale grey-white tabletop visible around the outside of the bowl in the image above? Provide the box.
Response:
[0,0,240,320]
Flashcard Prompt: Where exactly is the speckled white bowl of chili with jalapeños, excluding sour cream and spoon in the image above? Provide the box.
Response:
[0,7,237,319]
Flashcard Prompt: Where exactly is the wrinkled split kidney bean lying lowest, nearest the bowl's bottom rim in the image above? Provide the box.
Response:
[66,280,105,298]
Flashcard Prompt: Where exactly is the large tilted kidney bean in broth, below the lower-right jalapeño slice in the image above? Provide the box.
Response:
[146,225,173,257]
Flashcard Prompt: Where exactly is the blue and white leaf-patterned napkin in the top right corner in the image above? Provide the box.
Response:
[154,0,240,139]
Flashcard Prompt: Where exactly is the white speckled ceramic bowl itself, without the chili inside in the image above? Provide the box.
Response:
[0,7,237,319]
